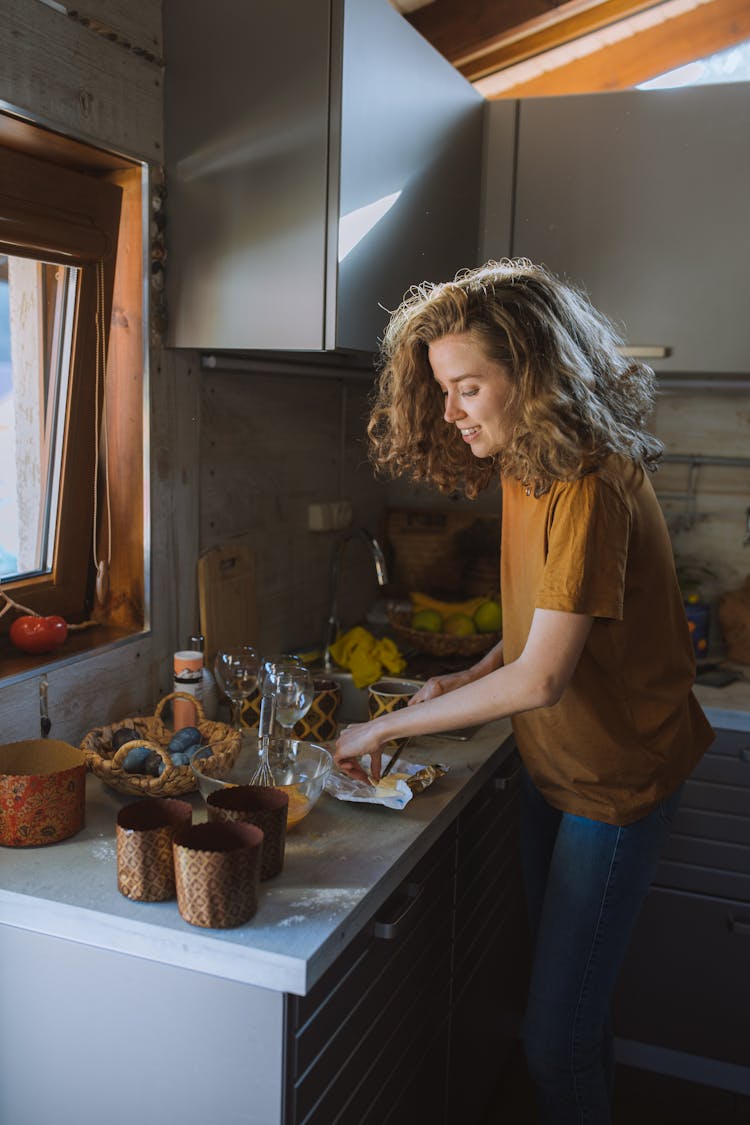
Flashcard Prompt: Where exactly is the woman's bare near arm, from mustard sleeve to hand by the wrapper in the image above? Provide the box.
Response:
[334,610,594,780]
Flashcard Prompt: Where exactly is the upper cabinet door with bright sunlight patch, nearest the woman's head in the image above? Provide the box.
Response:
[327,0,483,351]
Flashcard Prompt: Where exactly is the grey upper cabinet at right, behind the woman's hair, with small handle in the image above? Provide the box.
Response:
[513,83,750,374]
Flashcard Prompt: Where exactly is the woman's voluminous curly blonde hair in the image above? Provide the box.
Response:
[368,258,663,497]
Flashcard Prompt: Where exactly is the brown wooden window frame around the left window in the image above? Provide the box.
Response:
[0,127,147,674]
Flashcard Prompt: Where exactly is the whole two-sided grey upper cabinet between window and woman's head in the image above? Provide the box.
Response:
[164,0,484,351]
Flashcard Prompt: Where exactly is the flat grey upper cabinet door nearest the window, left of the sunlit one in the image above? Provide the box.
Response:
[164,0,331,350]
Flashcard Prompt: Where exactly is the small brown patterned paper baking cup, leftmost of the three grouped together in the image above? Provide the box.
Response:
[116,797,192,902]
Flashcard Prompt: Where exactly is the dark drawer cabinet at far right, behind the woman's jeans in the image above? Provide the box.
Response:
[615,730,750,1068]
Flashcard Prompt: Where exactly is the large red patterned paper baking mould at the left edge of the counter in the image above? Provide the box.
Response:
[0,738,85,847]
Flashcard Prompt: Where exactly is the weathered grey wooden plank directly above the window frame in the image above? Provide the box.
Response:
[0,0,163,162]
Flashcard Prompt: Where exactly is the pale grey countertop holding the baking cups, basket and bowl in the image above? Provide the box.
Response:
[0,720,510,995]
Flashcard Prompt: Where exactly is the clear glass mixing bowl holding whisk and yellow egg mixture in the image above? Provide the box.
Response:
[191,735,333,828]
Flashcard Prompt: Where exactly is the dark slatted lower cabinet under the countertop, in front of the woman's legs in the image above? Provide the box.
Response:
[284,733,525,1125]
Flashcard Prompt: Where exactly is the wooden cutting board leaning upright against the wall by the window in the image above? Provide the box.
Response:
[198,543,257,667]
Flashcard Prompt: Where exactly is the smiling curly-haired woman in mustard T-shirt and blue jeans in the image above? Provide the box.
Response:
[335,260,713,1125]
